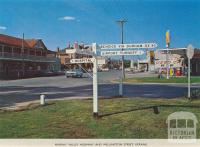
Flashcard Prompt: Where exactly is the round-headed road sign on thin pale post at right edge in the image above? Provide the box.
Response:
[186,44,194,98]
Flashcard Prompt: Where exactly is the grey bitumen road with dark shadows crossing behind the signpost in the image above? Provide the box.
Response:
[0,71,199,107]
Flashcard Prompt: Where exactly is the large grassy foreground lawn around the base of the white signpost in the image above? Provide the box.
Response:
[0,98,200,138]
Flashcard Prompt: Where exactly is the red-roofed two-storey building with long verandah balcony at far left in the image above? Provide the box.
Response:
[0,34,59,79]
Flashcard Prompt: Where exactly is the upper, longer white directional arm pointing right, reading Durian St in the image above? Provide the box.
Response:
[99,43,157,49]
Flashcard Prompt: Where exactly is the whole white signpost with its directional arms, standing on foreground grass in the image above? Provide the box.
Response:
[90,43,157,118]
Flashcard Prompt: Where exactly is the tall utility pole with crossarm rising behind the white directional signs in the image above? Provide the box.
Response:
[116,19,127,96]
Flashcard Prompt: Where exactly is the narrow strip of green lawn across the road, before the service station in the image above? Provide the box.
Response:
[124,77,200,83]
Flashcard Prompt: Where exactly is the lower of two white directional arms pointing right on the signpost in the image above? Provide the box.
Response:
[101,50,144,56]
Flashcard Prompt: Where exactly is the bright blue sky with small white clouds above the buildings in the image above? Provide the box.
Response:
[0,0,200,50]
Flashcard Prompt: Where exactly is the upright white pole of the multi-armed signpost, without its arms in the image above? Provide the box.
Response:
[92,43,98,118]
